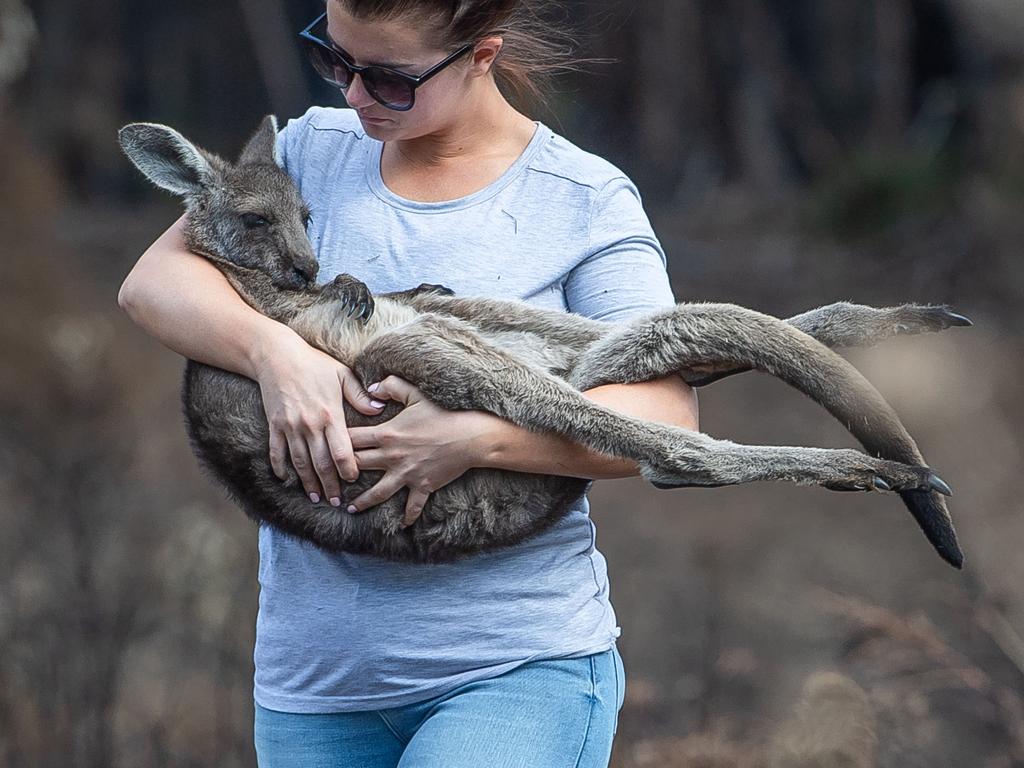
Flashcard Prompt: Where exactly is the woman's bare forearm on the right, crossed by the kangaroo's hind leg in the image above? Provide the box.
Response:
[481,376,699,479]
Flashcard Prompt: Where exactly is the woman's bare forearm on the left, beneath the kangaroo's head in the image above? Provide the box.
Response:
[118,217,301,379]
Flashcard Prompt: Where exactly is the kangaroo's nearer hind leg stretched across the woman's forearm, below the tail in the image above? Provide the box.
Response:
[354,315,933,490]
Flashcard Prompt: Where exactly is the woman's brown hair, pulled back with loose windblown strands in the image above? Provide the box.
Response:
[337,0,583,103]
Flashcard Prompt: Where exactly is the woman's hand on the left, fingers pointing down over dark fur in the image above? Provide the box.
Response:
[256,330,384,507]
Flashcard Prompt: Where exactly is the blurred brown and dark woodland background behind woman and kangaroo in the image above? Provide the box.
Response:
[0,0,1024,768]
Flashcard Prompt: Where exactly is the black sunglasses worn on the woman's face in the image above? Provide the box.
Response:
[299,12,475,112]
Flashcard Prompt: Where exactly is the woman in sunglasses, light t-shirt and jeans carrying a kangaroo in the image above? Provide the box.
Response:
[119,0,697,768]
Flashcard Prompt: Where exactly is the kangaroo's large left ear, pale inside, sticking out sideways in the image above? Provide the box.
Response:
[118,123,215,197]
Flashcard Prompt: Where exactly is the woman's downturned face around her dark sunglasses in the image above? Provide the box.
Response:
[327,0,472,141]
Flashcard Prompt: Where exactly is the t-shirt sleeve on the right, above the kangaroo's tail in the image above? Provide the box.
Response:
[565,176,676,322]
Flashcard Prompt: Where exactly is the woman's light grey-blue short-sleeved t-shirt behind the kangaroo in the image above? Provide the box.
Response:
[255,108,674,713]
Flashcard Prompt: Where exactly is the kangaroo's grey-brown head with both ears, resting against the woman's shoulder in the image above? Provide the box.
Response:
[118,115,317,290]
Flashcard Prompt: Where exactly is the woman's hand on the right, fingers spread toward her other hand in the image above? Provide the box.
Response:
[348,376,504,526]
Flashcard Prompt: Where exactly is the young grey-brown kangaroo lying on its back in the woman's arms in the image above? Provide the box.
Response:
[119,116,970,567]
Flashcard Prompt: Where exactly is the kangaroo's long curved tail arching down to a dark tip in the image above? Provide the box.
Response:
[572,304,964,568]
